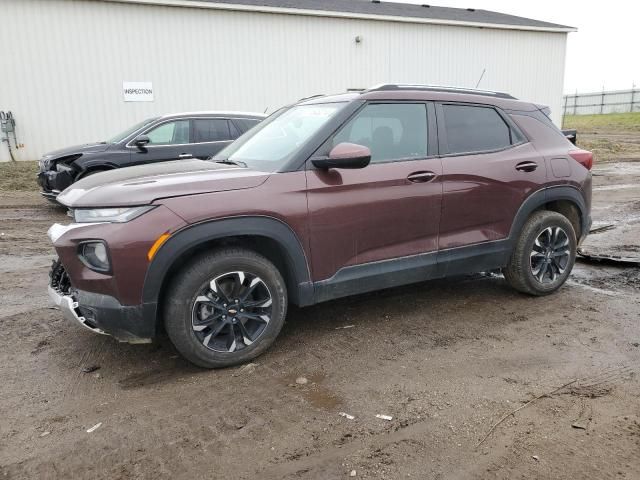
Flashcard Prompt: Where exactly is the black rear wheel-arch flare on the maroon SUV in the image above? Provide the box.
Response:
[509,185,591,244]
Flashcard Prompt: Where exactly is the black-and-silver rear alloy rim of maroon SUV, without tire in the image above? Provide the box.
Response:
[530,227,571,284]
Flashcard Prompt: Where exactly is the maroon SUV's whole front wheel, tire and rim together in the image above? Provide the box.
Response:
[164,248,287,368]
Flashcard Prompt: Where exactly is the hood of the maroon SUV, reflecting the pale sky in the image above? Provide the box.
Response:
[57,160,269,208]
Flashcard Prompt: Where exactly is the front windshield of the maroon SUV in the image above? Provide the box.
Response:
[214,102,346,172]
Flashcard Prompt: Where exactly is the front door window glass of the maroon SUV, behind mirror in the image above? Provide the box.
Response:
[333,103,427,162]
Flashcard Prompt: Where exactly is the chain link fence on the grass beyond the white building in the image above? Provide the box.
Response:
[564,89,640,115]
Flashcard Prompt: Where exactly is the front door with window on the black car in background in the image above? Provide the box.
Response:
[129,119,193,164]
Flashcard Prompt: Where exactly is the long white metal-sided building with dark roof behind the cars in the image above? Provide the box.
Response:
[0,0,574,160]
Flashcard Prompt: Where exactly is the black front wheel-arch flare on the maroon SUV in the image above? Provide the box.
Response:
[142,216,313,319]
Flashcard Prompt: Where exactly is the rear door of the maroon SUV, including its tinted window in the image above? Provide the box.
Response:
[436,103,546,249]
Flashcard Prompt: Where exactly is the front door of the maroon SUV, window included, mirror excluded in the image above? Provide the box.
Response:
[307,102,442,284]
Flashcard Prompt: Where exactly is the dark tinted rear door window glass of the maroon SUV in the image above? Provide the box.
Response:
[442,105,512,154]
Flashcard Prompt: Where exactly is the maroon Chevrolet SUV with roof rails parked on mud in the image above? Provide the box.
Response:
[49,85,593,367]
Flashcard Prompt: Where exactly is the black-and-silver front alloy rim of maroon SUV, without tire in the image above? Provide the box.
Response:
[191,271,273,353]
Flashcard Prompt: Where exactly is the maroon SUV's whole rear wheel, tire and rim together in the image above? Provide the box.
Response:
[502,210,577,296]
